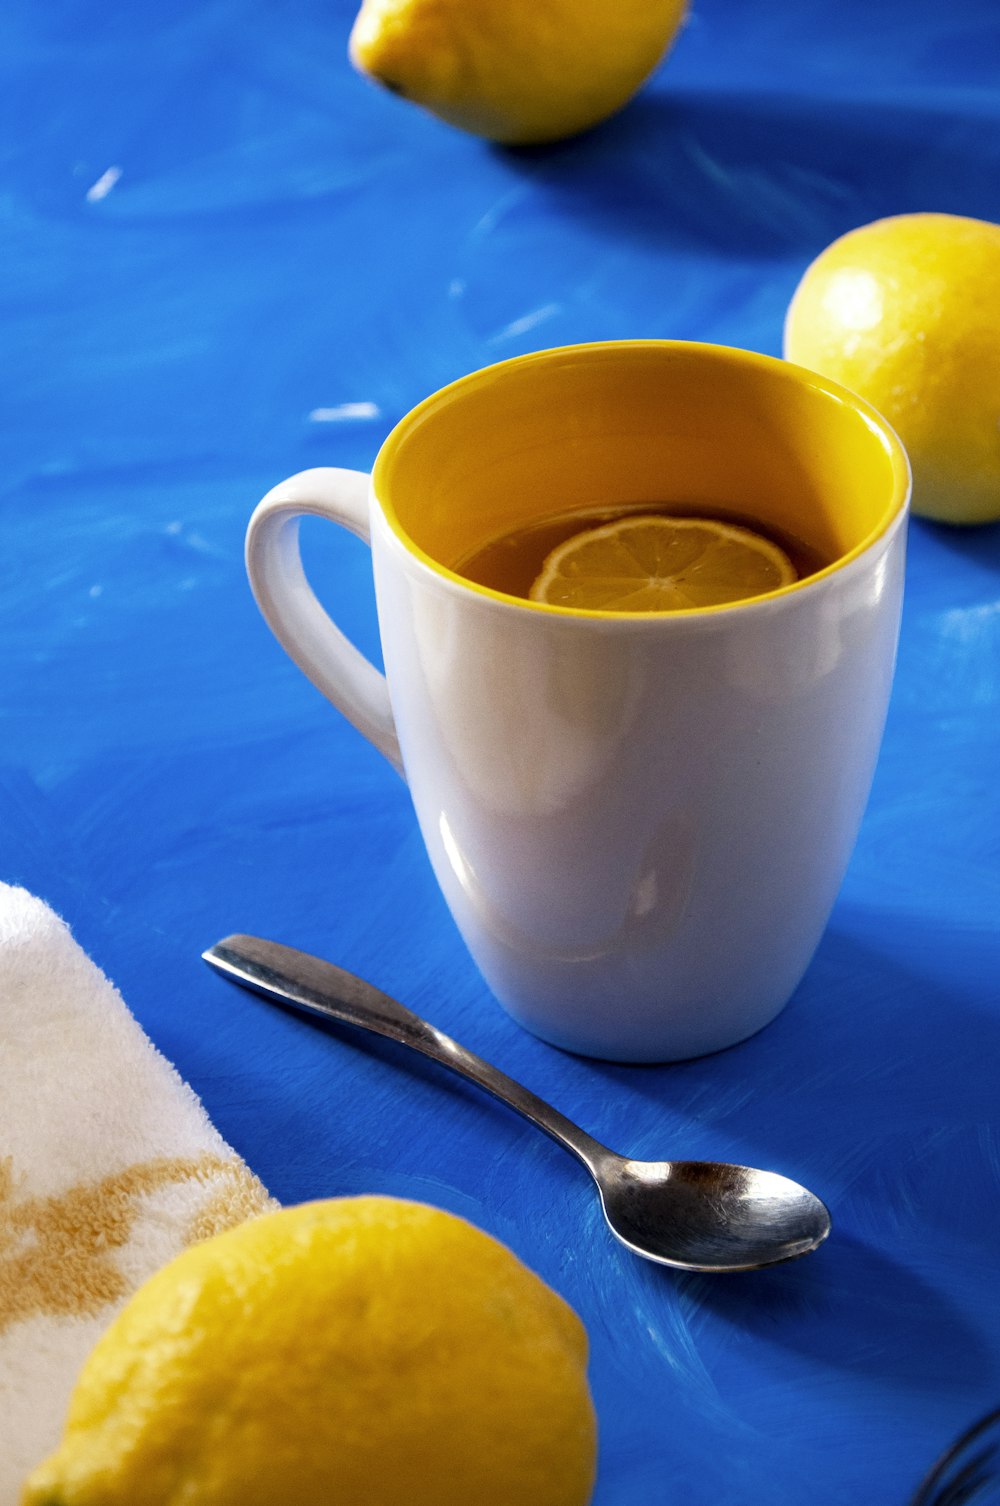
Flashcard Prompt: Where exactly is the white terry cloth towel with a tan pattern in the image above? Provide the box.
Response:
[0,884,271,1506]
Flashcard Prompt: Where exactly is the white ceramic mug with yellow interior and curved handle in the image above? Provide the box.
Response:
[247,340,910,1062]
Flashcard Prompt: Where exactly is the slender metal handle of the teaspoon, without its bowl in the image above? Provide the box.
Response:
[202,935,610,1175]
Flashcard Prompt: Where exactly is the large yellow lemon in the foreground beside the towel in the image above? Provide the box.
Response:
[21,1197,595,1506]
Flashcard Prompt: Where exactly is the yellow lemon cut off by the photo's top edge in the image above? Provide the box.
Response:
[349,0,687,143]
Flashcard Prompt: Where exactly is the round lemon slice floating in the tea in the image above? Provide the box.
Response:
[529,514,797,611]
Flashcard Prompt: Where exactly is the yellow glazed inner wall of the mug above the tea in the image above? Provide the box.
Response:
[373,340,910,616]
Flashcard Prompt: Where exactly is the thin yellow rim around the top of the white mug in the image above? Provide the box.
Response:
[370,339,913,623]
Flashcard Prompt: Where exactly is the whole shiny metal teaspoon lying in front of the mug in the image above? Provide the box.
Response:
[202,935,830,1271]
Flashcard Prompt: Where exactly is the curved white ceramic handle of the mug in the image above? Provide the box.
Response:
[245,465,405,779]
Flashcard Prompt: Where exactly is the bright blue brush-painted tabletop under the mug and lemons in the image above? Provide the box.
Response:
[0,0,1000,1506]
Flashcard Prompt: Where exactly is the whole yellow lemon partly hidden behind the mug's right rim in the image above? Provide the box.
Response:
[785,214,1000,523]
